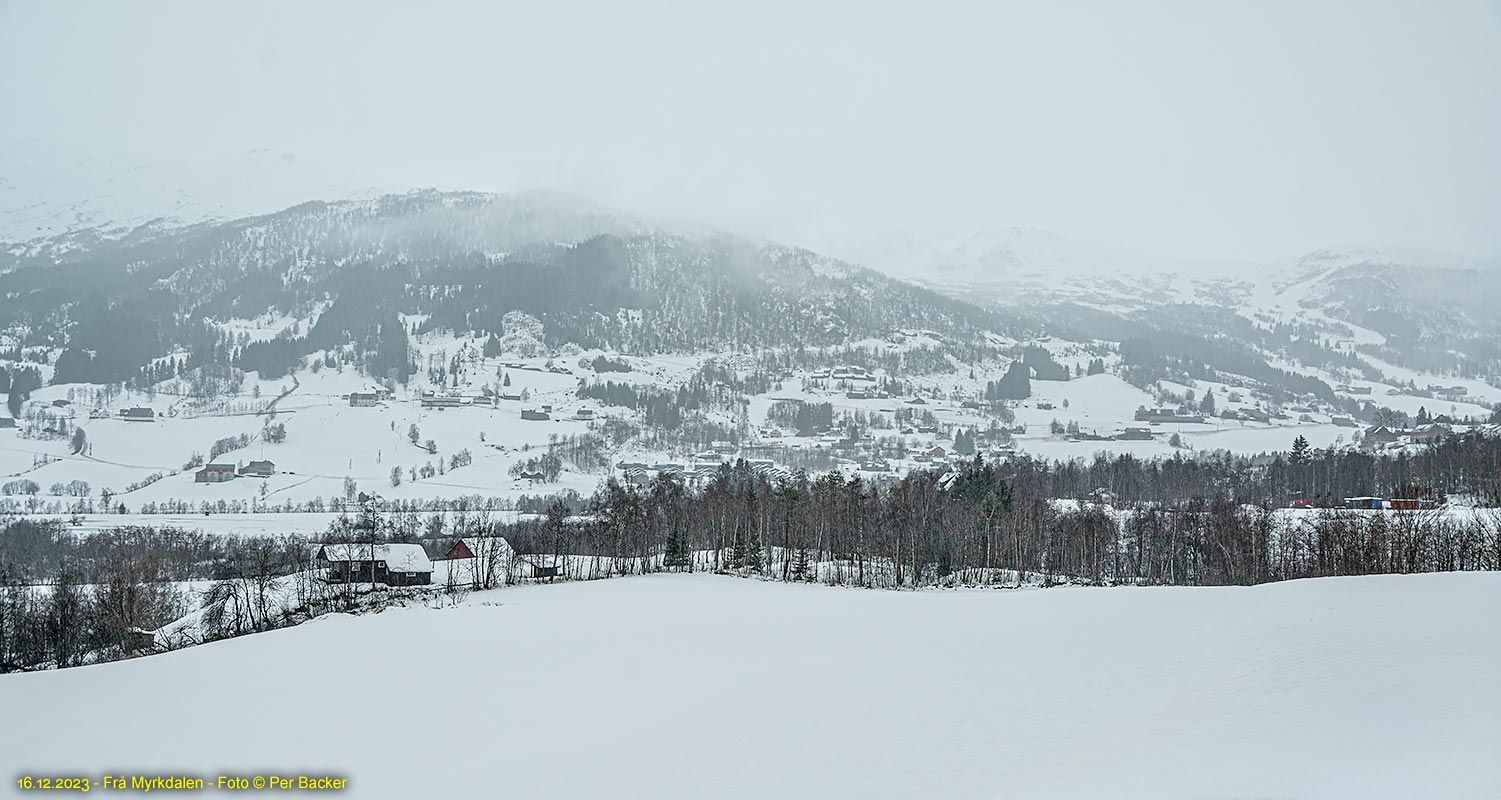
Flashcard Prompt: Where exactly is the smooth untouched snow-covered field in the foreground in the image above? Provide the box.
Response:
[0,573,1501,798]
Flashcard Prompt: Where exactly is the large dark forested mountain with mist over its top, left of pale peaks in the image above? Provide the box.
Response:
[0,191,1019,383]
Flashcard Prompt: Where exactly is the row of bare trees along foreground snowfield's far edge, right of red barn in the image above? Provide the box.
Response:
[503,459,1501,588]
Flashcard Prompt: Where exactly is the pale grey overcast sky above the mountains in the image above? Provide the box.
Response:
[0,0,1501,260]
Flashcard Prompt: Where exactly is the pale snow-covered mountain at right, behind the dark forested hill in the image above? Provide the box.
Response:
[800,227,1501,371]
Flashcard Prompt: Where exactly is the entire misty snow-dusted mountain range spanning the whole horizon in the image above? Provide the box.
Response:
[0,167,1501,417]
